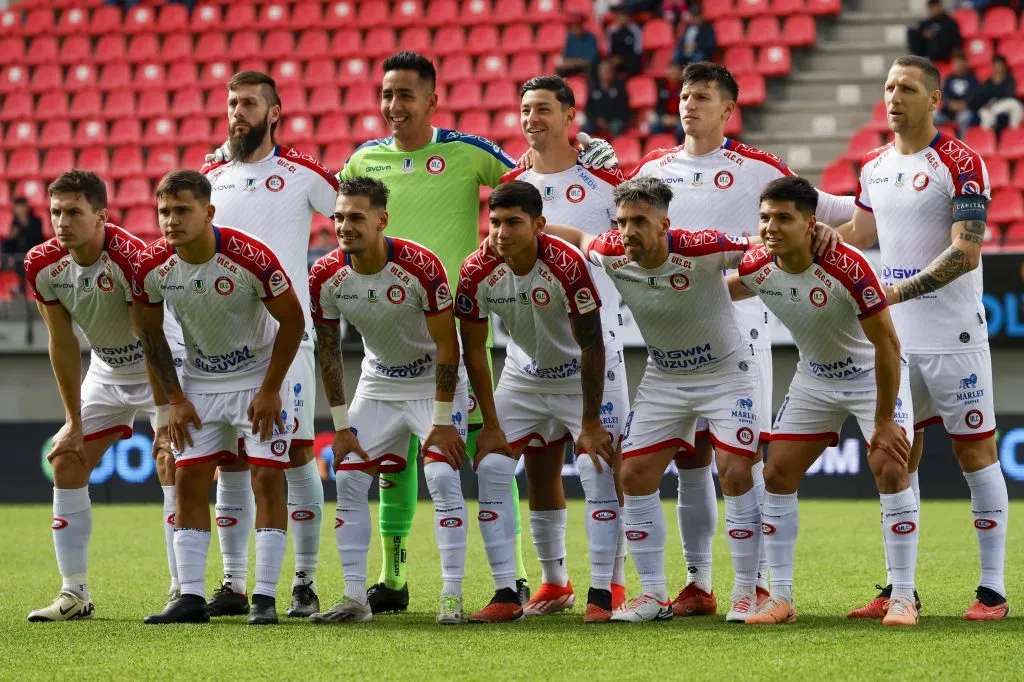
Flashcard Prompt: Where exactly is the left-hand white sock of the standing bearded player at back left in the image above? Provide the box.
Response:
[214,470,256,594]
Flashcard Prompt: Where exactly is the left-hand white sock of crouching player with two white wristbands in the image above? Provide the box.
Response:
[334,471,374,604]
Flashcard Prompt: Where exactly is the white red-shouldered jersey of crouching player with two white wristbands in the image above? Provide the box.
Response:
[309,239,452,400]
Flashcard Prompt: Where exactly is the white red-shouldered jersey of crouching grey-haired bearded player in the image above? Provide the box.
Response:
[587,228,754,376]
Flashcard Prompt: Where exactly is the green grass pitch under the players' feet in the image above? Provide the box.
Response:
[0,500,1024,682]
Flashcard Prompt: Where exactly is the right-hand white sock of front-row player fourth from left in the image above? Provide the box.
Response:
[577,455,623,591]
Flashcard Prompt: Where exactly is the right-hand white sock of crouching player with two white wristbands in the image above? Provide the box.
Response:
[423,460,467,596]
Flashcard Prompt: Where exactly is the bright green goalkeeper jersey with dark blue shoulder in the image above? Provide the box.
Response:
[338,128,515,291]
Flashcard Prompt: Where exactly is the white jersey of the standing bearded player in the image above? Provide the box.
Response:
[201,146,338,347]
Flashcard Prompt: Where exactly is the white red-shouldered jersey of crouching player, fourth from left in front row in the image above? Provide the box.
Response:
[456,233,606,395]
